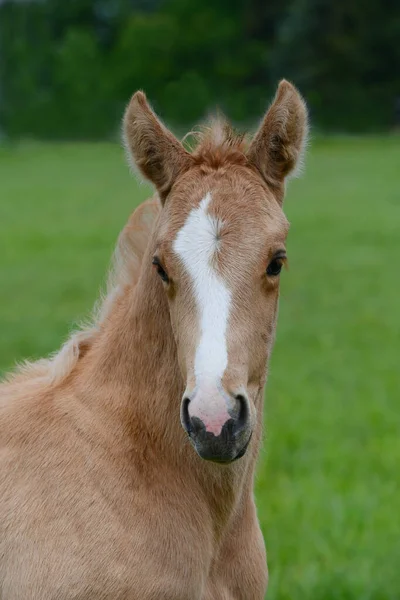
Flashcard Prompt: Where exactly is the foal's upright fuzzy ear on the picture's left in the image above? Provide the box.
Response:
[123,92,193,203]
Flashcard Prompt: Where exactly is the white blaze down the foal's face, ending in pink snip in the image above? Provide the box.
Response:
[173,193,231,435]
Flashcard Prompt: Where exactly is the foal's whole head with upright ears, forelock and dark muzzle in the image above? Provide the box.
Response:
[124,81,307,463]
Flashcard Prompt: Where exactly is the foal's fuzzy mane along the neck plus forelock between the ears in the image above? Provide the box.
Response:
[5,118,247,385]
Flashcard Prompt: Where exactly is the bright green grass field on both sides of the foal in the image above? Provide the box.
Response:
[0,136,400,600]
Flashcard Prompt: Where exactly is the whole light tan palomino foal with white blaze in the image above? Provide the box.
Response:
[0,81,307,600]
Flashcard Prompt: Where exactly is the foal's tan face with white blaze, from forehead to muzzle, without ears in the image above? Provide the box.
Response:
[153,167,288,462]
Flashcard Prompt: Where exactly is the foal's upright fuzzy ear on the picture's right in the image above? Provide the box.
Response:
[247,80,308,201]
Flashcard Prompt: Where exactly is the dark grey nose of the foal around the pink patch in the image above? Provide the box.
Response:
[181,394,251,463]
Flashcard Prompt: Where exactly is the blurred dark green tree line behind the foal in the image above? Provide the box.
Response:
[0,0,400,138]
